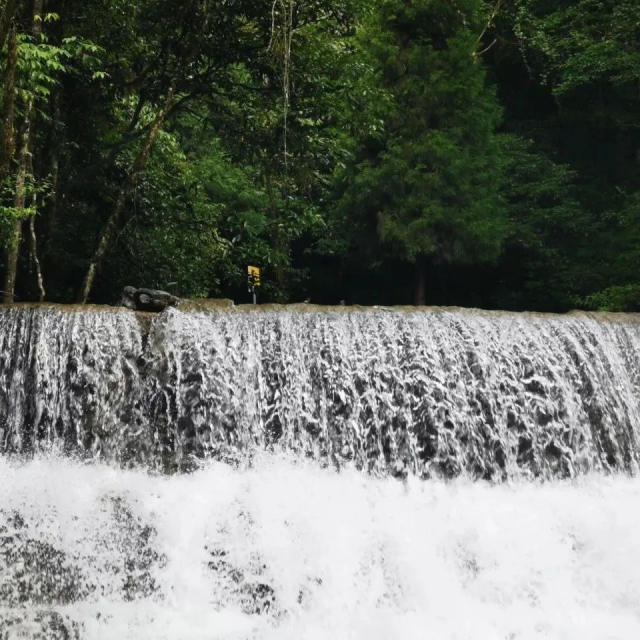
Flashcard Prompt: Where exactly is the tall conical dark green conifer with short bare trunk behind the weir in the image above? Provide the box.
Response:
[341,0,506,304]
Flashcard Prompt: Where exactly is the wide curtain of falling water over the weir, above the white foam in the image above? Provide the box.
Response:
[0,306,640,479]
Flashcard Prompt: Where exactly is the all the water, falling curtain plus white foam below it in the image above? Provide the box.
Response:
[0,306,640,640]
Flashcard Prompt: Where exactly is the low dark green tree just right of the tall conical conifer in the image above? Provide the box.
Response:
[494,135,602,311]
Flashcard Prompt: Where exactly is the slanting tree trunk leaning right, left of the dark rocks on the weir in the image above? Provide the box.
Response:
[77,78,177,304]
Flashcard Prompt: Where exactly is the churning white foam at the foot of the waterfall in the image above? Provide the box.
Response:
[0,454,640,640]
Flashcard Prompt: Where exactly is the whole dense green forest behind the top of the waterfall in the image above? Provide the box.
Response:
[0,0,640,312]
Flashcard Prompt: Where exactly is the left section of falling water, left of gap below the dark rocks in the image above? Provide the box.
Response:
[0,306,142,458]
